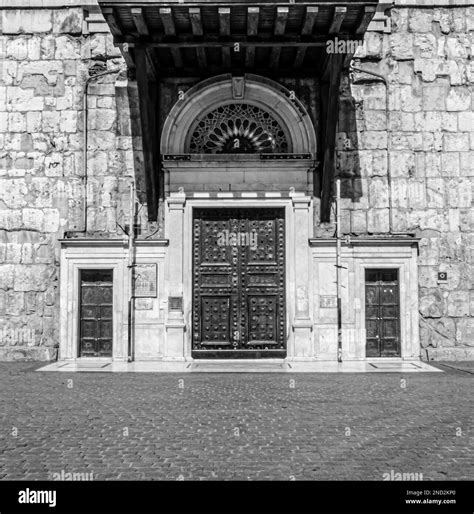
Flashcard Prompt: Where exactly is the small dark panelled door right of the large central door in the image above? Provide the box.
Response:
[365,269,401,357]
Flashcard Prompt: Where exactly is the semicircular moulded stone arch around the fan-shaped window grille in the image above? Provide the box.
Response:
[160,74,316,158]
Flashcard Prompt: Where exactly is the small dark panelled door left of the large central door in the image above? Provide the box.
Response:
[79,269,113,357]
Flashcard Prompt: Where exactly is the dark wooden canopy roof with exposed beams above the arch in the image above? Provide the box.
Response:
[99,0,378,78]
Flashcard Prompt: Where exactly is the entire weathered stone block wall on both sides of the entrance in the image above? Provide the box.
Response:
[0,2,474,359]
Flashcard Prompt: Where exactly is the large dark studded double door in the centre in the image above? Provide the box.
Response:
[192,208,286,358]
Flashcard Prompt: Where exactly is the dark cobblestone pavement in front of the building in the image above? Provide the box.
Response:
[0,363,474,480]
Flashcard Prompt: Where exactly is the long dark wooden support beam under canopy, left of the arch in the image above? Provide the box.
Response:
[135,47,159,221]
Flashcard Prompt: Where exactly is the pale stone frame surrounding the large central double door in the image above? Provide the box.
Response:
[165,192,314,361]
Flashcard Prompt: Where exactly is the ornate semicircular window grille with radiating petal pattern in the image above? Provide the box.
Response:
[189,103,289,154]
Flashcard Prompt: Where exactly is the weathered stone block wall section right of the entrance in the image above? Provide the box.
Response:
[330,7,474,359]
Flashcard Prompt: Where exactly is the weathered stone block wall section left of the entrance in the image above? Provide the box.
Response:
[0,8,137,359]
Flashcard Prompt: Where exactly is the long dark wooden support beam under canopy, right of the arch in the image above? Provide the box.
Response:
[320,54,344,222]
